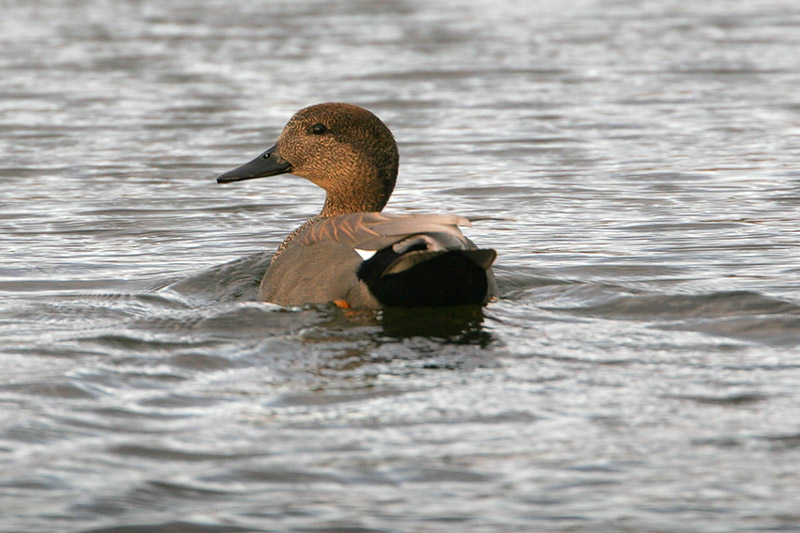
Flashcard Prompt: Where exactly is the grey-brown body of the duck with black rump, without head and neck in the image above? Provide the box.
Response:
[261,213,496,308]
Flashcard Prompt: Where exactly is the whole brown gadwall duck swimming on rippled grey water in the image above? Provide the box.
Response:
[217,103,497,309]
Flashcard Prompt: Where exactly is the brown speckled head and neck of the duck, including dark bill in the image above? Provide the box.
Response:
[217,103,398,216]
